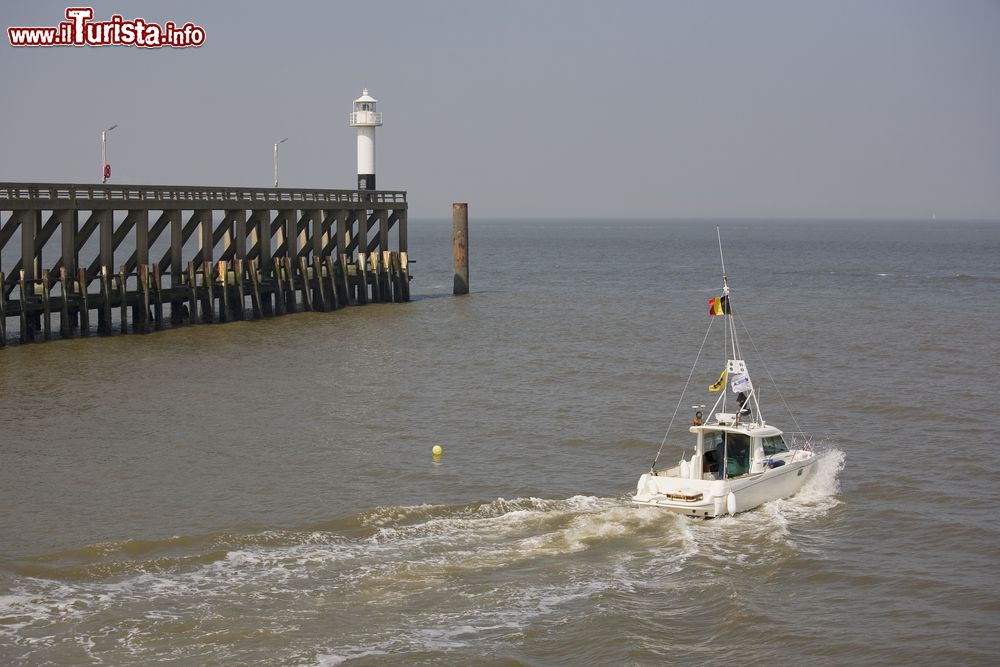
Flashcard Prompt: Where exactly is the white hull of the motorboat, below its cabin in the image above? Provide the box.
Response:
[632,450,816,518]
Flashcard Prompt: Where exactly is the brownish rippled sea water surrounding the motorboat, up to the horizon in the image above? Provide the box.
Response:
[0,221,1000,665]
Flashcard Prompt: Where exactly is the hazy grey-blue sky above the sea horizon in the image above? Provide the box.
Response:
[0,0,1000,219]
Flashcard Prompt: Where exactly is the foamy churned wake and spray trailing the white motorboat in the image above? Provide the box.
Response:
[0,468,843,664]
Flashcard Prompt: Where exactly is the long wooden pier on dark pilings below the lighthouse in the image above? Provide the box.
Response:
[0,183,410,346]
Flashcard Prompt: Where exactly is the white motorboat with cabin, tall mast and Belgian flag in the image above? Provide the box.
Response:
[632,230,817,518]
